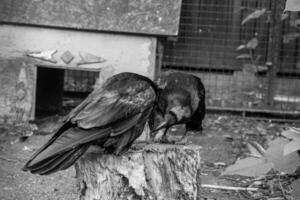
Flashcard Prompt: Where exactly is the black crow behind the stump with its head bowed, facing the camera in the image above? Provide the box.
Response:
[149,71,205,141]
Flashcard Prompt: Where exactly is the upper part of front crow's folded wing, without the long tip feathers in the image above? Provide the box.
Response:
[67,83,155,129]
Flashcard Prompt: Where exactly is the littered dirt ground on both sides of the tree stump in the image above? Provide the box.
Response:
[0,114,299,200]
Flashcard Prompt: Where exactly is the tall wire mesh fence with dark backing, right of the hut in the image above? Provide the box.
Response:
[161,0,300,113]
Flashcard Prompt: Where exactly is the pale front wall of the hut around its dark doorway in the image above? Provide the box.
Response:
[0,25,156,122]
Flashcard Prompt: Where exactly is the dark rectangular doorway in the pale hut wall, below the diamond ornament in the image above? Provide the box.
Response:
[35,66,99,120]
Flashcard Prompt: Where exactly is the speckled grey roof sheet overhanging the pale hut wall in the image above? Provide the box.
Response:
[0,0,181,35]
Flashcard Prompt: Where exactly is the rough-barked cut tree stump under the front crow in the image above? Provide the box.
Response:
[75,144,201,200]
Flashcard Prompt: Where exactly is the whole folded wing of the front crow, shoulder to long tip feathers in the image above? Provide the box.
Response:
[28,84,155,167]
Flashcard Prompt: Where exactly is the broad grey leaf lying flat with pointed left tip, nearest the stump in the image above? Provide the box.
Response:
[222,157,273,176]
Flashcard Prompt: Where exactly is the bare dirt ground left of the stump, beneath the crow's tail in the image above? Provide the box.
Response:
[0,133,78,200]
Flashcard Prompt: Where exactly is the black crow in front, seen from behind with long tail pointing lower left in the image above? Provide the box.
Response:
[23,73,156,175]
